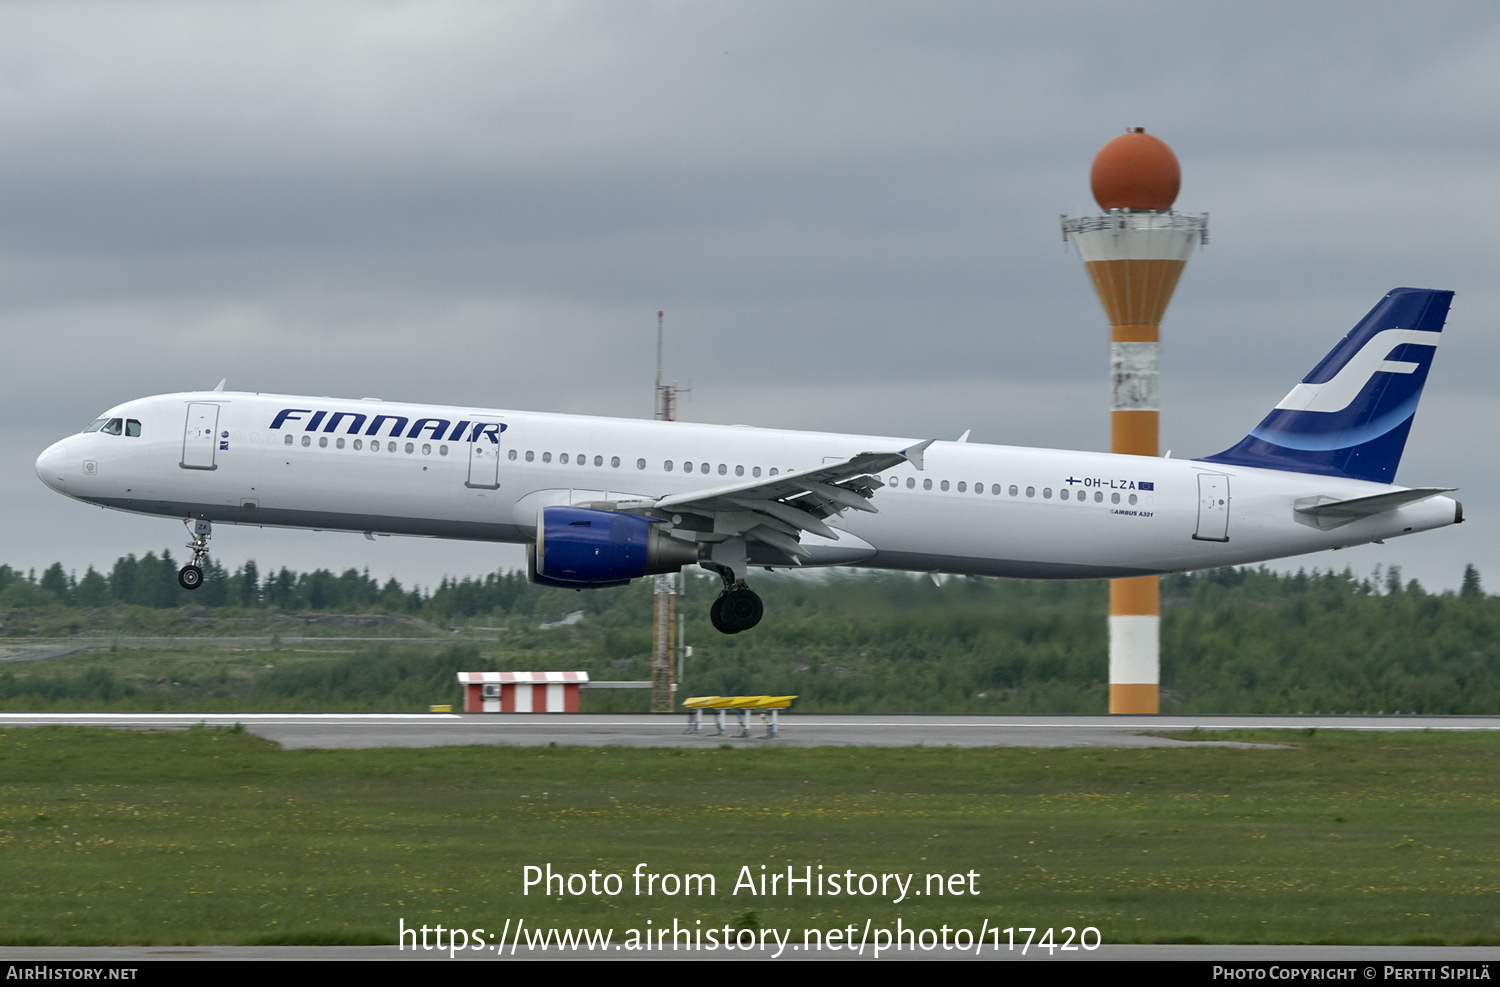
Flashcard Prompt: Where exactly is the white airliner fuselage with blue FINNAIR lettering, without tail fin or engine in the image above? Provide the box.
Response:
[38,392,1461,579]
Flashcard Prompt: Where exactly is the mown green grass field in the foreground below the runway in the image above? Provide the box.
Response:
[0,728,1500,945]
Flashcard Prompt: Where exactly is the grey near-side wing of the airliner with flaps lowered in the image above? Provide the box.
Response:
[645,440,936,558]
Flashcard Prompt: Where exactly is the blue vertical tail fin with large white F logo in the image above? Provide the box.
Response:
[1203,288,1454,483]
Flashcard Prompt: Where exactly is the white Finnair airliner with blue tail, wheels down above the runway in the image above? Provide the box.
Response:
[36,288,1463,633]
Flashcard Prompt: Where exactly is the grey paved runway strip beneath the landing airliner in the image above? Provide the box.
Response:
[0,713,1500,749]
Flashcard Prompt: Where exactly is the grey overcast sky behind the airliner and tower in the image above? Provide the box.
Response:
[0,0,1500,590]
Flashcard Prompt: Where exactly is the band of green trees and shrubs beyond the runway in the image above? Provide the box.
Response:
[0,552,1500,714]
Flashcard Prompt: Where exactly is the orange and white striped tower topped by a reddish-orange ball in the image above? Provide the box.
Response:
[1062,128,1209,713]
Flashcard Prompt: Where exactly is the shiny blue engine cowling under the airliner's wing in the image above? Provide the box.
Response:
[527,507,698,590]
